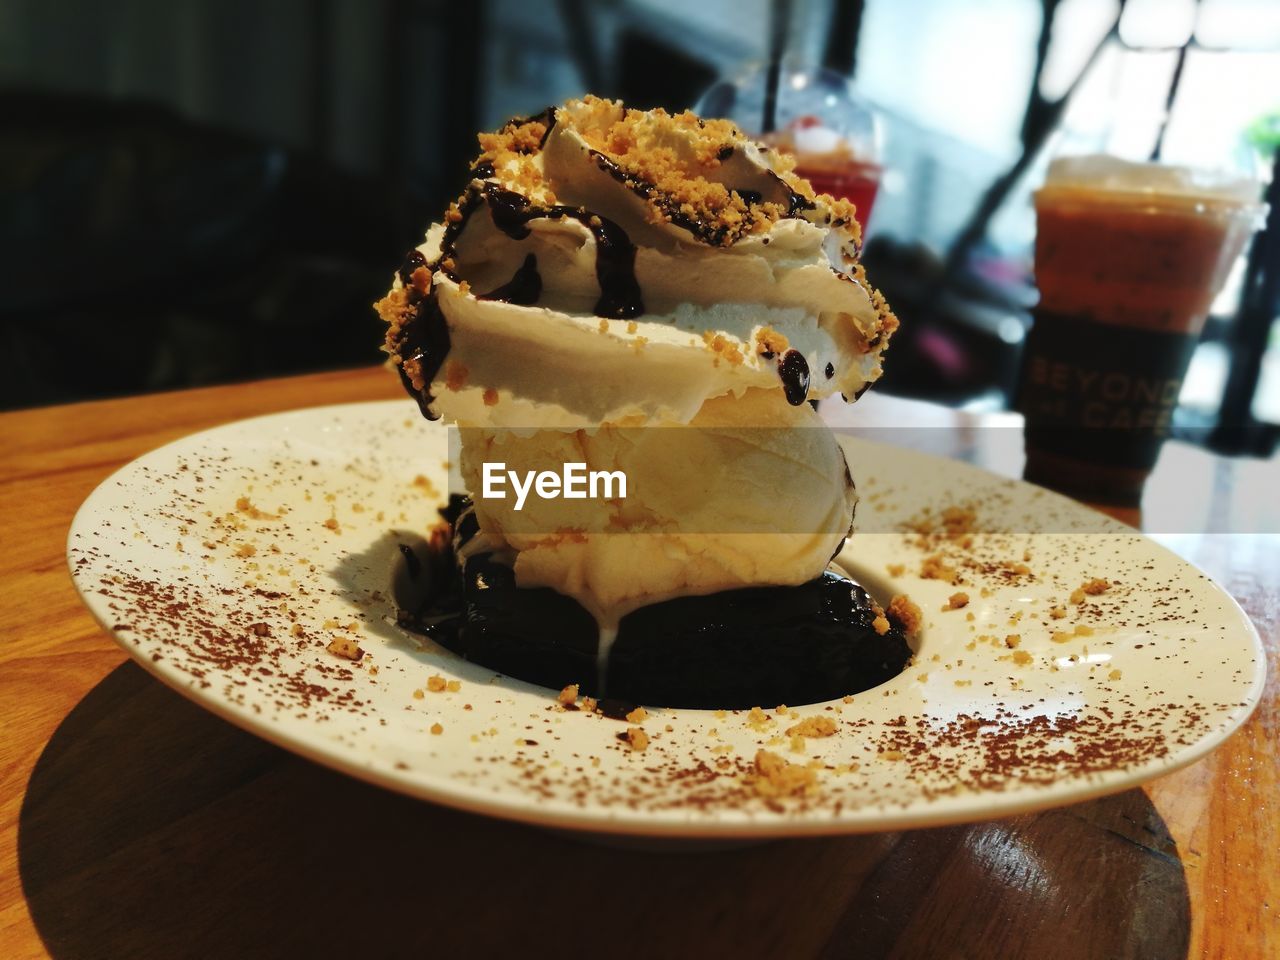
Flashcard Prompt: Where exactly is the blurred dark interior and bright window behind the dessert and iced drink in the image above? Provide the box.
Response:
[0,0,1280,456]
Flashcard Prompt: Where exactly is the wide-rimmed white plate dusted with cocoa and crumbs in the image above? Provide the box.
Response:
[68,402,1263,837]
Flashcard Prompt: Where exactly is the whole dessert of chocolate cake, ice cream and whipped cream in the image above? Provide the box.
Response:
[378,97,910,708]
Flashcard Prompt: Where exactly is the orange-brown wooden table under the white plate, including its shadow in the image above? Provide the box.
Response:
[0,370,1280,959]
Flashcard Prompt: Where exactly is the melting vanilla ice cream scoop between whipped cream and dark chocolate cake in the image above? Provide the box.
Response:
[461,389,856,623]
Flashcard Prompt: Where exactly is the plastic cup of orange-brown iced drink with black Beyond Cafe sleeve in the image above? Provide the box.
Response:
[1018,156,1265,504]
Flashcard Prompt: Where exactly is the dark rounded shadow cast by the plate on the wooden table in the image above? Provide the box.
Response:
[18,664,1189,960]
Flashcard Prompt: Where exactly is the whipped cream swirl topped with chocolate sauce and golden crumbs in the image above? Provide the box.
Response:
[379,97,897,429]
